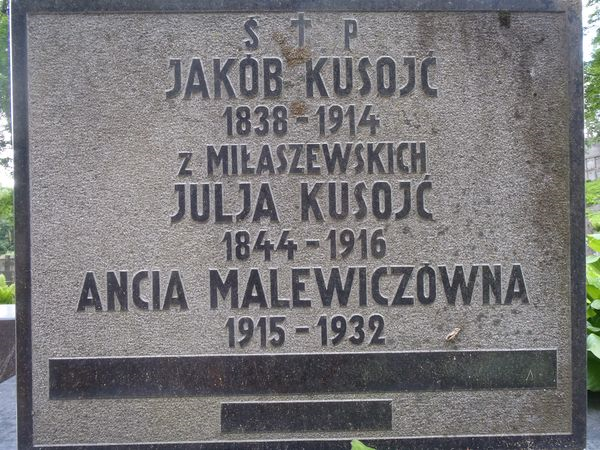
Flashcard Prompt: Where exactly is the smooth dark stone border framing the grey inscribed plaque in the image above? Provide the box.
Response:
[10,0,586,450]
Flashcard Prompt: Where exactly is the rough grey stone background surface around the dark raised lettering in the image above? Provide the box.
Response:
[19,7,571,444]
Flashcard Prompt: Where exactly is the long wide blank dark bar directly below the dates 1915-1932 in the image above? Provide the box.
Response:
[50,350,556,400]
